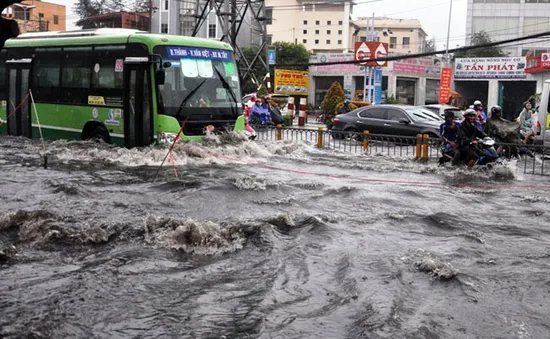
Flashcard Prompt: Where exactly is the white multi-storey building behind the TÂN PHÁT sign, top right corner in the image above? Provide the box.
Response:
[466,0,550,57]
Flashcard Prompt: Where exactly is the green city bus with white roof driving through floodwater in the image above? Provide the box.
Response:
[0,28,246,148]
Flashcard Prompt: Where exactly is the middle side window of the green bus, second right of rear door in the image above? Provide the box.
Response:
[61,47,93,105]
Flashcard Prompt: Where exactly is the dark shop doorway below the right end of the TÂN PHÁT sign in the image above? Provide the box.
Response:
[498,81,537,120]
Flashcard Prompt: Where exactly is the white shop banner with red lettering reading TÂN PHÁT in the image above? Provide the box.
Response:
[455,57,527,79]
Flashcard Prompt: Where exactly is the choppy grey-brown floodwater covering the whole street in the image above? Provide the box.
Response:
[0,137,550,339]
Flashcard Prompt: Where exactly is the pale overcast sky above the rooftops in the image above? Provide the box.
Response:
[50,0,467,49]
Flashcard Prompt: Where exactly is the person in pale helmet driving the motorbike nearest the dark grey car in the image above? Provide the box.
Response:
[452,109,487,168]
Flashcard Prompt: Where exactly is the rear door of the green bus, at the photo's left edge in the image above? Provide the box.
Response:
[6,59,32,138]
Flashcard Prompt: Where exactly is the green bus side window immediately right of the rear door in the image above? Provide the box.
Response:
[32,48,61,103]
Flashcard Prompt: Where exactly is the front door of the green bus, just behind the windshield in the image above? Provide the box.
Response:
[123,57,153,148]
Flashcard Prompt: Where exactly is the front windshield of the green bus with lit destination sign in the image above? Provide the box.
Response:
[154,46,241,121]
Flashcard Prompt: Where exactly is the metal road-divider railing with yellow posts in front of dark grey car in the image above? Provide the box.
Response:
[253,125,550,175]
